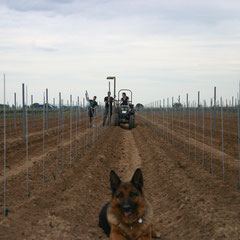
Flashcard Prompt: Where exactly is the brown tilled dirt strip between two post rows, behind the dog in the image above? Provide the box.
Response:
[0,122,240,240]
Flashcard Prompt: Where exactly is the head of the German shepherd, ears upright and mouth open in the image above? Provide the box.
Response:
[110,168,146,223]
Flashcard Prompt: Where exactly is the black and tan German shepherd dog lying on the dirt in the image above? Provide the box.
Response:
[99,168,160,240]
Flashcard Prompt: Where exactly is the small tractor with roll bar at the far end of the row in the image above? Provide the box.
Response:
[114,89,135,130]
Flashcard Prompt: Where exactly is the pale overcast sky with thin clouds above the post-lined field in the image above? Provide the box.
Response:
[0,0,240,103]
